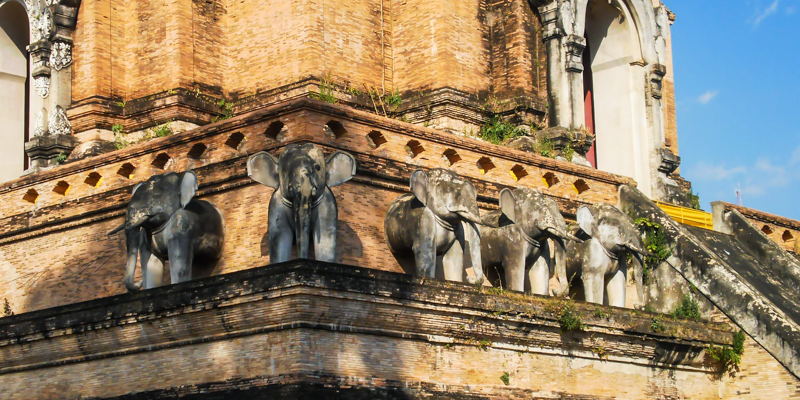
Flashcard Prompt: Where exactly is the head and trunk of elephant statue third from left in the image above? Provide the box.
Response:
[410,168,483,284]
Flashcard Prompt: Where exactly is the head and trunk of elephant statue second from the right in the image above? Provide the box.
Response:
[500,187,582,294]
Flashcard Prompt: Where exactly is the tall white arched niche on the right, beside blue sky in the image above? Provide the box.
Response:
[583,0,651,192]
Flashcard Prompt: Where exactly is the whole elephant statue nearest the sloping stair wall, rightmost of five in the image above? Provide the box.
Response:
[567,204,650,307]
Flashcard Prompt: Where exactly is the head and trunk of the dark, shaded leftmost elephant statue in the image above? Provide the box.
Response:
[109,171,197,291]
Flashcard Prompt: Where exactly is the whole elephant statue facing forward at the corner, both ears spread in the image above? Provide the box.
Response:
[247,143,356,264]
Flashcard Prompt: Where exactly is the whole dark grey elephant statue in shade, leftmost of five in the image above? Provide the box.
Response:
[109,171,225,291]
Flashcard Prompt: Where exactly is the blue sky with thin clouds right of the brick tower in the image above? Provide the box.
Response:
[664,0,800,219]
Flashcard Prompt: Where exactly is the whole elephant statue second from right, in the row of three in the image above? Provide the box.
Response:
[481,187,582,295]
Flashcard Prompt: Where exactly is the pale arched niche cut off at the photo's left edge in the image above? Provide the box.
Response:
[0,1,30,182]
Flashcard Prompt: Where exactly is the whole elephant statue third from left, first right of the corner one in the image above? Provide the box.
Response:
[384,168,483,284]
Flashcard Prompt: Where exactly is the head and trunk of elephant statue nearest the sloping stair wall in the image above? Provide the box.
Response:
[577,204,651,299]
